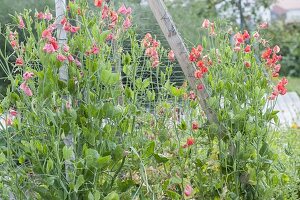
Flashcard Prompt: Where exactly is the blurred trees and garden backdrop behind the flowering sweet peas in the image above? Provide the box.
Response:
[0,0,300,95]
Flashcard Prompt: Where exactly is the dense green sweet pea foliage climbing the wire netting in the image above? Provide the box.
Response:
[0,0,299,200]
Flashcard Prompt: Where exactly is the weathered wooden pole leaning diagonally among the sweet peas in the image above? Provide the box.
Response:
[148,0,218,124]
